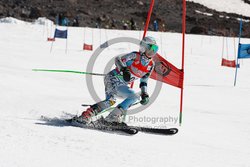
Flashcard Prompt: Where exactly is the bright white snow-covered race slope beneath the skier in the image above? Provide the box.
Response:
[0,17,250,167]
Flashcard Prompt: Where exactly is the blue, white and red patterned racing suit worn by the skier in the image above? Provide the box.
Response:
[88,52,154,120]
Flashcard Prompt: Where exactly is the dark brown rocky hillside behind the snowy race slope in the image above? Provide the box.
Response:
[0,0,250,37]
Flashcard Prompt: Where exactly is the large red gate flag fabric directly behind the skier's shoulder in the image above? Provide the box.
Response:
[150,54,184,88]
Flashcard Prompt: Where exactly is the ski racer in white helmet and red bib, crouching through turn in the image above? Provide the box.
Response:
[77,37,158,124]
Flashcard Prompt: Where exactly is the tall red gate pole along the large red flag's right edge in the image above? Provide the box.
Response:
[179,0,186,126]
